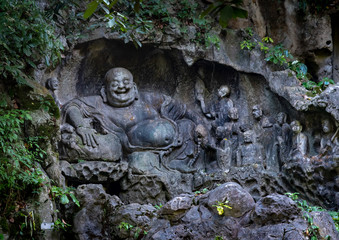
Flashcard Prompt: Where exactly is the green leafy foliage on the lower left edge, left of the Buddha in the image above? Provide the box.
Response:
[0,109,45,213]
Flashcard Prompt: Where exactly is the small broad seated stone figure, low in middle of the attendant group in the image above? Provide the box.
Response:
[237,130,265,166]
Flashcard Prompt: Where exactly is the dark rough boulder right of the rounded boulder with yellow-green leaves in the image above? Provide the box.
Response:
[252,194,301,226]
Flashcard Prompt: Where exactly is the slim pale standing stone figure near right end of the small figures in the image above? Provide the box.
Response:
[291,120,308,158]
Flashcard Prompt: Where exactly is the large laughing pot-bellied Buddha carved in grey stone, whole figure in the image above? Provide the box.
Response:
[62,68,208,172]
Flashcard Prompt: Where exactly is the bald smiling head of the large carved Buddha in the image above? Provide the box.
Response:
[106,68,136,107]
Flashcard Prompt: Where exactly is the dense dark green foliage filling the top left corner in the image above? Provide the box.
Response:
[0,0,63,84]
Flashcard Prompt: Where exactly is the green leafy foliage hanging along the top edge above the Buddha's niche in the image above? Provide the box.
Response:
[84,0,247,47]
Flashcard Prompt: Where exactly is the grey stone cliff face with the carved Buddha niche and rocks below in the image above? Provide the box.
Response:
[13,0,339,239]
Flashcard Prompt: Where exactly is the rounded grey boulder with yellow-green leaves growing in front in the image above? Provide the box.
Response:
[207,182,255,217]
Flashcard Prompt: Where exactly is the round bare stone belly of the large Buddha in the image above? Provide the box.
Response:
[127,119,176,148]
